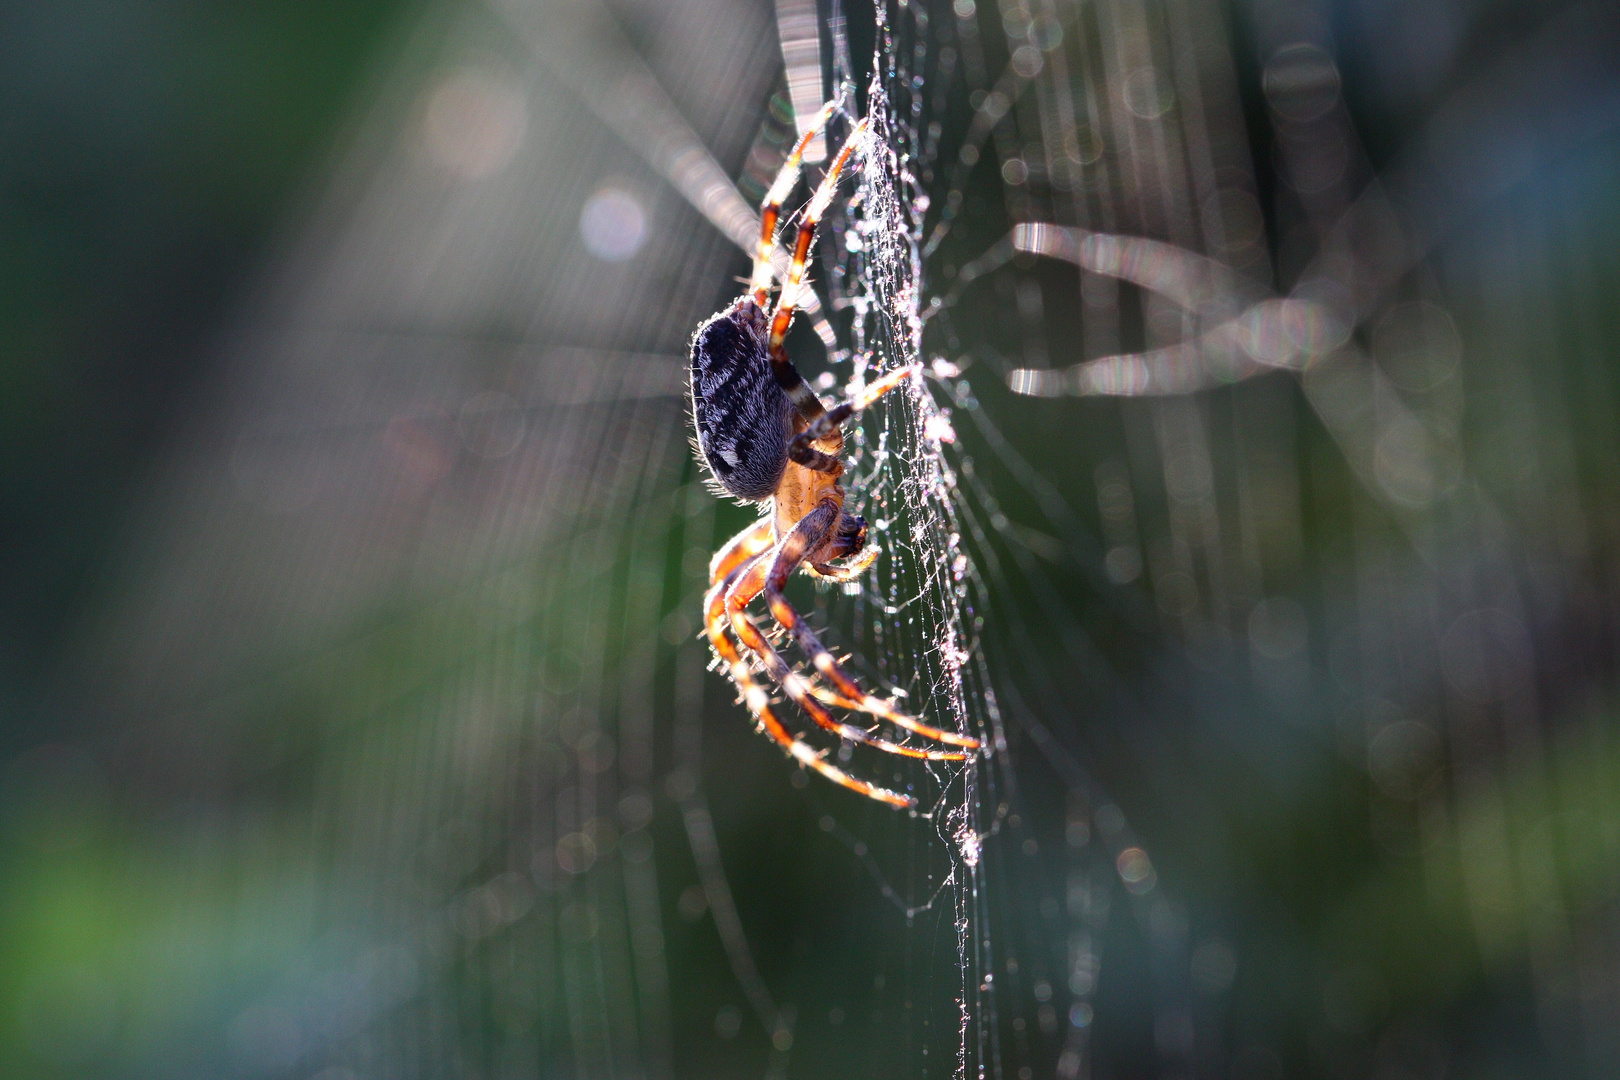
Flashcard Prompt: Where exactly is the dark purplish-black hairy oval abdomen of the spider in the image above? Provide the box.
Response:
[690,298,794,500]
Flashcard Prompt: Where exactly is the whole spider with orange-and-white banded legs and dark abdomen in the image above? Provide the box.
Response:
[690,102,978,810]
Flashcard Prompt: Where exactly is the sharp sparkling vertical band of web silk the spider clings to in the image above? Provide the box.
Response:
[816,8,1004,1077]
